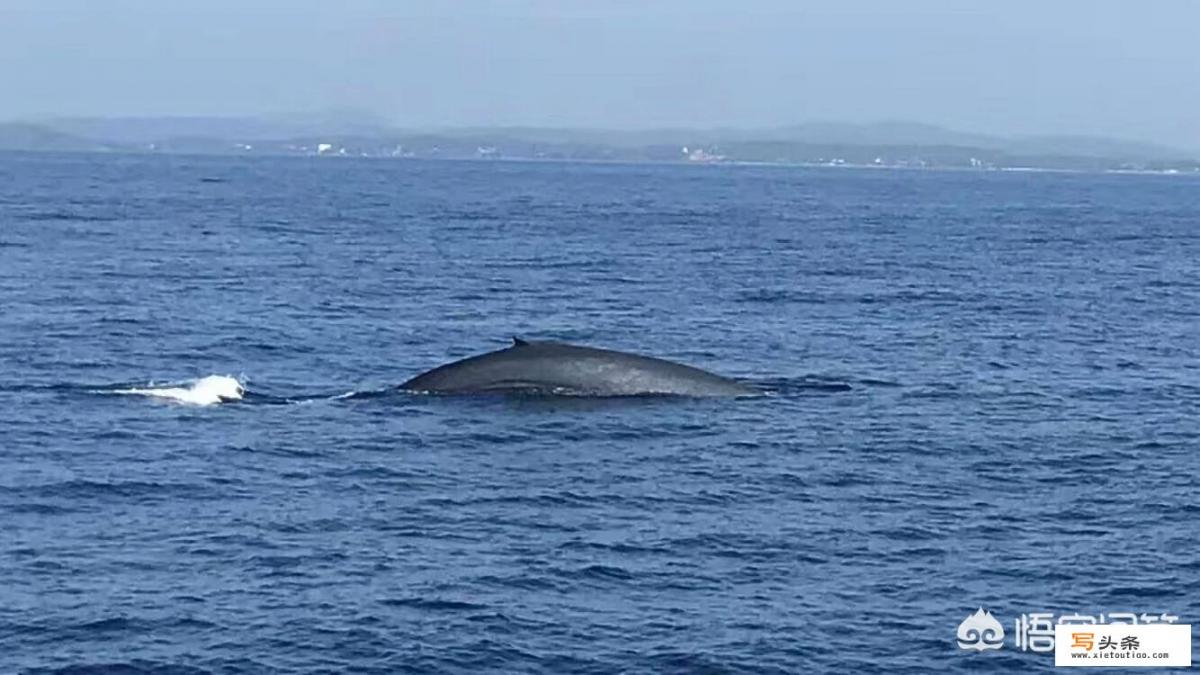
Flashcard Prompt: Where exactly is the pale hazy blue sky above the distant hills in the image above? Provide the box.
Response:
[0,0,1200,149]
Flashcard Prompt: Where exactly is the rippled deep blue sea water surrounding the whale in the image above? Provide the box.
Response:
[0,154,1200,674]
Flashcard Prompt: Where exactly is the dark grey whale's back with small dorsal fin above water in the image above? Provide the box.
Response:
[398,338,760,396]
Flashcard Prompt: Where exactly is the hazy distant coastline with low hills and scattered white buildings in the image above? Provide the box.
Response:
[0,118,1200,174]
